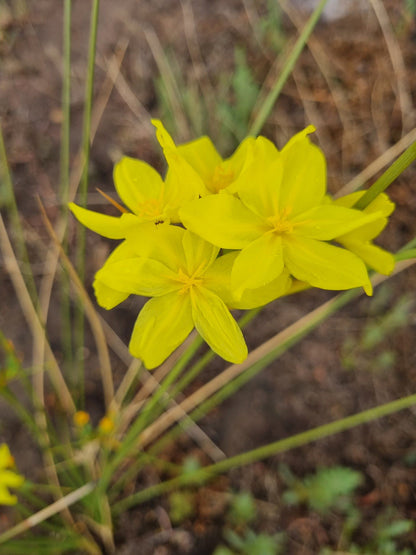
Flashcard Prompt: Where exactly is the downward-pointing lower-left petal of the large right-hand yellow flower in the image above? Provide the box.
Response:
[231,232,284,298]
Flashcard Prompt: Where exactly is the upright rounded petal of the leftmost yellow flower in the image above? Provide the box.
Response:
[114,156,164,217]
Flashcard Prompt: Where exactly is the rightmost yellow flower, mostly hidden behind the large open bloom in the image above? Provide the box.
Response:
[332,191,395,275]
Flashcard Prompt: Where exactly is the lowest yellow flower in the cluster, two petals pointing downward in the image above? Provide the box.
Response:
[96,226,247,368]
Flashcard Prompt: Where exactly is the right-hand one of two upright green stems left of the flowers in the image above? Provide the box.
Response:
[75,0,100,402]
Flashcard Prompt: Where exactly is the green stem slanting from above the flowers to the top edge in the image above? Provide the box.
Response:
[249,0,328,135]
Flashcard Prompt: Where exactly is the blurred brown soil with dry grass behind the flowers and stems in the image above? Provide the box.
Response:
[0,0,416,555]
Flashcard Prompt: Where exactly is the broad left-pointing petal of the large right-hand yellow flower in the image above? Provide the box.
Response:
[179,193,267,249]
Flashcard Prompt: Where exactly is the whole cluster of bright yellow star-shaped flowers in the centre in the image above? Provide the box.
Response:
[70,120,394,368]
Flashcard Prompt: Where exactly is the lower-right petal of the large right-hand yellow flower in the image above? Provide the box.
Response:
[284,235,371,294]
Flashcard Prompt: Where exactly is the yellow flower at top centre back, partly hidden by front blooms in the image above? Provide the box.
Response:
[152,120,255,196]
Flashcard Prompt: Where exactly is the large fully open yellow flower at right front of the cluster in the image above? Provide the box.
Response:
[179,126,379,296]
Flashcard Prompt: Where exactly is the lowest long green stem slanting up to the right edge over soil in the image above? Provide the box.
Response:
[113,394,416,515]
